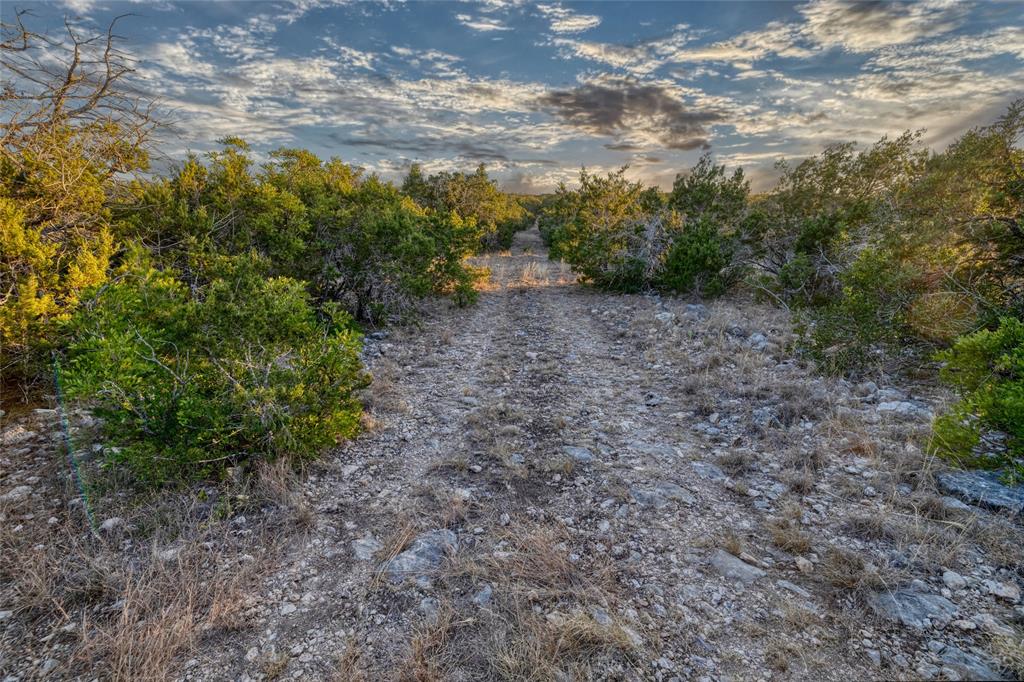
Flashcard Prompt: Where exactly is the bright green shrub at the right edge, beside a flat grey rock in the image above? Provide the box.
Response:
[932,317,1024,480]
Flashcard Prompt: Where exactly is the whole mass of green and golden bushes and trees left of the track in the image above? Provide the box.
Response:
[0,18,527,485]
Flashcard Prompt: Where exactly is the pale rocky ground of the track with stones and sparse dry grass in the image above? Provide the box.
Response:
[6,231,1024,680]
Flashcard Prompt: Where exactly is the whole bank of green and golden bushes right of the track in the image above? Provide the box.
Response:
[540,100,1024,477]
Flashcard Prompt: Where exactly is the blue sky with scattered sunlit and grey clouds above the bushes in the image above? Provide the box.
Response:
[8,0,1024,193]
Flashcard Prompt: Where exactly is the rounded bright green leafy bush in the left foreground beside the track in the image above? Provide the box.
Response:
[65,248,367,484]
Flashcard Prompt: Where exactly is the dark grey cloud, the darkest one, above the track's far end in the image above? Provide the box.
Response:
[538,78,724,150]
